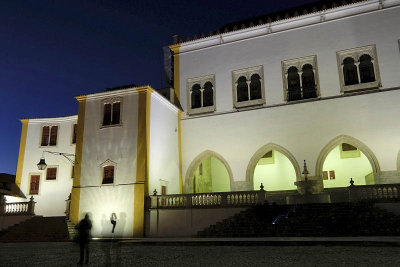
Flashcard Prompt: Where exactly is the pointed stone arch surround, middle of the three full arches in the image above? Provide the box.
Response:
[246,143,301,186]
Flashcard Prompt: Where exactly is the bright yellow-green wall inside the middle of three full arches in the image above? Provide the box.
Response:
[253,150,297,191]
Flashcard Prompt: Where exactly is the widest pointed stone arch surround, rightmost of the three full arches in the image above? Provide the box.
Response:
[315,135,381,177]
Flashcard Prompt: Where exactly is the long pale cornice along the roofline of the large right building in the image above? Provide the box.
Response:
[175,0,400,53]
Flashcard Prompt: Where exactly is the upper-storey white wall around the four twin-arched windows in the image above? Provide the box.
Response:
[179,7,400,112]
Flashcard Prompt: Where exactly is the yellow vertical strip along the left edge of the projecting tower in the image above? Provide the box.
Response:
[70,96,86,224]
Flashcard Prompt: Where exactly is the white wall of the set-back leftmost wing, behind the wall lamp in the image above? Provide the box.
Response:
[17,116,77,216]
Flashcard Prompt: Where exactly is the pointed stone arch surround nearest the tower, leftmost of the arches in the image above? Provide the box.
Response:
[184,150,233,193]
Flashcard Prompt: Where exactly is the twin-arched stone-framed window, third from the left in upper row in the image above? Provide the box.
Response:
[282,56,319,102]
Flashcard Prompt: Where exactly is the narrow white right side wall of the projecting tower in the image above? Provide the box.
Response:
[149,93,179,194]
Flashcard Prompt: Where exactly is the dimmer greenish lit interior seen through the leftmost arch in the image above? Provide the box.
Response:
[194,157,230,193]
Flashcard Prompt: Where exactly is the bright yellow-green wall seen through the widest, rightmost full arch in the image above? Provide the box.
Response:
[322,145,372,187]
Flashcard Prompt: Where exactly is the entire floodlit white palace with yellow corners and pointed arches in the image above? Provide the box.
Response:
[7,0,400,237]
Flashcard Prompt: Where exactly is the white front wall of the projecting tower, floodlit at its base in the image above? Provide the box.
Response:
[79,90,139,237]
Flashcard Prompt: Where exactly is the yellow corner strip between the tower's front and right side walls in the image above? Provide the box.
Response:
[133,87,154,237]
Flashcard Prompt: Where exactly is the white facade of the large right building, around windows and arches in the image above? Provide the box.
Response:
[179,1,400,193]
